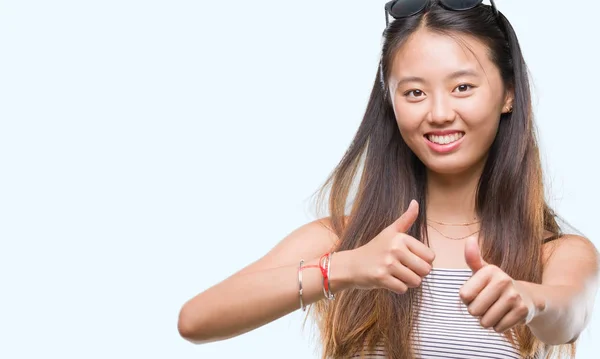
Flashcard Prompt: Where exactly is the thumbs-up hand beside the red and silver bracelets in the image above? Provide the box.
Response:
[346,200,435,294]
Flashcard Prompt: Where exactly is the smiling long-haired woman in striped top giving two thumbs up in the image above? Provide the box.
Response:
[179,0,599,359]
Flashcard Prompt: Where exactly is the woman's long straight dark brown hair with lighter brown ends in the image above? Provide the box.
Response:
[312,2,574,359]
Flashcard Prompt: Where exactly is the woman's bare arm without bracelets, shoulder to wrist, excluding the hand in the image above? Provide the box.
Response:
[517,235,600,345]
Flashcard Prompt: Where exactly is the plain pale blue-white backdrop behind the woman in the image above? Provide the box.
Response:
[0,0,600,359]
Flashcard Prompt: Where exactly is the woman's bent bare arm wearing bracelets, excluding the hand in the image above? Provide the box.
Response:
[178,220,347,344]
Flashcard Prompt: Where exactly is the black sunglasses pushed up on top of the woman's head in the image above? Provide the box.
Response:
[385,0,498,28]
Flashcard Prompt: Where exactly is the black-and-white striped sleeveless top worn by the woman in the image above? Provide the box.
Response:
[353,268,521,359]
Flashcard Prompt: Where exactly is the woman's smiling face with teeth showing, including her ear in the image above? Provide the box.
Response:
[389,29,512,174]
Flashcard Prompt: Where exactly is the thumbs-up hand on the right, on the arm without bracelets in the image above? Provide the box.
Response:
[459,238,536,333]
